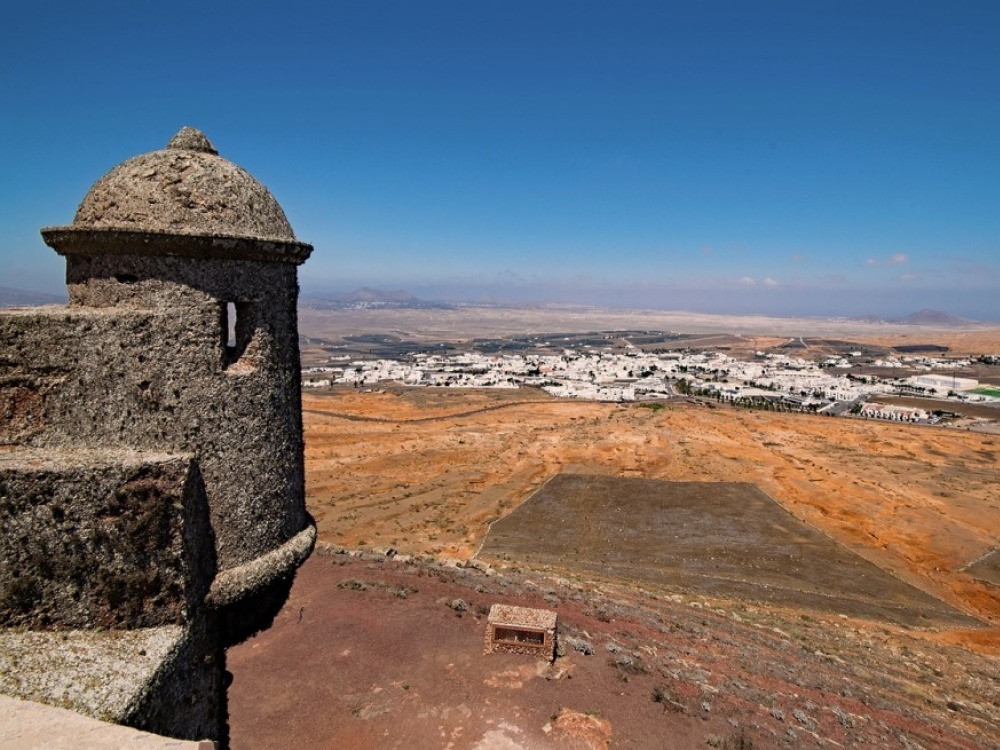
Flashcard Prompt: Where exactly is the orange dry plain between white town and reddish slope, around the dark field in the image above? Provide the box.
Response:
[304,388,1000,653]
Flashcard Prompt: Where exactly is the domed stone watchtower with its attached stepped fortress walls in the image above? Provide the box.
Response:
[0,128,315,742]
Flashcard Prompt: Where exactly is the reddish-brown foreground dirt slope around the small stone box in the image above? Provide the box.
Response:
[228,554,1000,750]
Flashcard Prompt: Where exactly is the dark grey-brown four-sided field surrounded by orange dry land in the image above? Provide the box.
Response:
[479,474,977,627]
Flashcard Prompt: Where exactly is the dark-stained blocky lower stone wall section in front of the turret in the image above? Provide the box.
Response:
[0,450,215,630]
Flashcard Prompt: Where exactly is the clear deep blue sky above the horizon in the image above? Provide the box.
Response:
[0,0,1000,320]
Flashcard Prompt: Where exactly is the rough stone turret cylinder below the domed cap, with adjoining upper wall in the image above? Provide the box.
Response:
[0,256,309,569]
